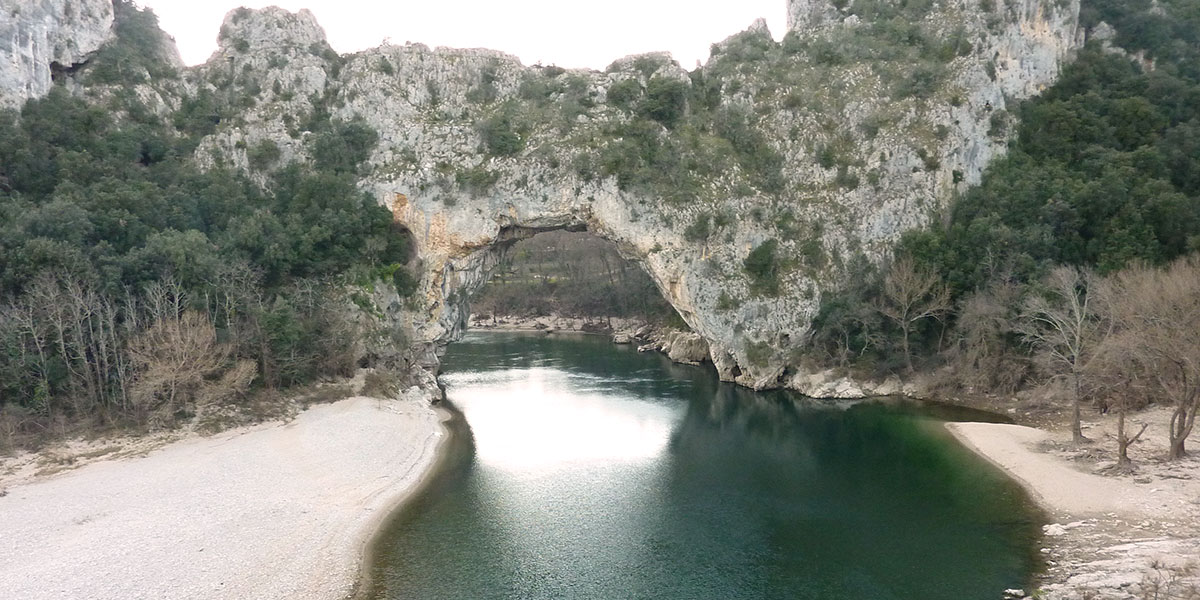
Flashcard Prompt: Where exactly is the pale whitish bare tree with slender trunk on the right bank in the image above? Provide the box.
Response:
[1018,266,1102,443]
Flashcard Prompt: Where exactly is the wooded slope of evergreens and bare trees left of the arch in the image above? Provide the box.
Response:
[0,2,412,449]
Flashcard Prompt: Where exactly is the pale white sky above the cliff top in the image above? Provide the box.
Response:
[138,0,786,70]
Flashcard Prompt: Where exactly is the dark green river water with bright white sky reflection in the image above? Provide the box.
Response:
[373,334,1039,600]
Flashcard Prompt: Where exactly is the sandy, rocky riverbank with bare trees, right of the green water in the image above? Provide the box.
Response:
[947,409,1200,600]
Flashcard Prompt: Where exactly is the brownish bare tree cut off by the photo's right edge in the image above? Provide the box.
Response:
[1104,257,1200,460]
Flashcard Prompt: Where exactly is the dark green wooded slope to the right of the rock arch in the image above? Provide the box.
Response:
[814,0,1200,451]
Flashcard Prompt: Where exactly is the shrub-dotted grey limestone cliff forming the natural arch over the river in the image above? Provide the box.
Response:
[180,0,1080,395]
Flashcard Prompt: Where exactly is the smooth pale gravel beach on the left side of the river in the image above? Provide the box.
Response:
[0,397,444,600]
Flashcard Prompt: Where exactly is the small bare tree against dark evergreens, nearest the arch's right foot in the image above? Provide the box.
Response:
[876,257,950,372]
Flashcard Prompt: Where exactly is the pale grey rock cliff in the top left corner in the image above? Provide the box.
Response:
[0,0,113,109]
